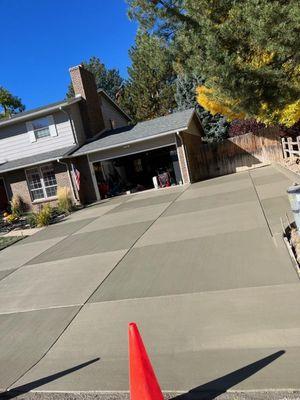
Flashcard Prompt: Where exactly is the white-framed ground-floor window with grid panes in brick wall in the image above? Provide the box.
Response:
[26,165,57,201]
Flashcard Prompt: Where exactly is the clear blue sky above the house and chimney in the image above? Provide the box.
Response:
[0,0,137,109]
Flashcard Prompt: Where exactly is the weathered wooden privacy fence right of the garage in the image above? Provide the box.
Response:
[192,129,283,181]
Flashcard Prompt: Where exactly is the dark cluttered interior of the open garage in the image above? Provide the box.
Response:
[93,145,182,199]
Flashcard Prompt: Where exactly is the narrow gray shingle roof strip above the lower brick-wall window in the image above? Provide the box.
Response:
[0,146,77,173]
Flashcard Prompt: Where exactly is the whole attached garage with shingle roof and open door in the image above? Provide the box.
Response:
[70,109,202,202]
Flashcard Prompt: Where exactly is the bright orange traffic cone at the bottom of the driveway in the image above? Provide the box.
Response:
[129,322,164,400]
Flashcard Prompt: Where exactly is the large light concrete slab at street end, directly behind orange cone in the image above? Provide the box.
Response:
[12,282,300,391]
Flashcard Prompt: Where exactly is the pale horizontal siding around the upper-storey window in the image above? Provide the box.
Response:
[0,111,74,163]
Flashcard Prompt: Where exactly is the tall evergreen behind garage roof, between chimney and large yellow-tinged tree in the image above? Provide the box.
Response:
[119,31,176,121]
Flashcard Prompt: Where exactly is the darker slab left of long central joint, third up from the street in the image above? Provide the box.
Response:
[28,221,151,264]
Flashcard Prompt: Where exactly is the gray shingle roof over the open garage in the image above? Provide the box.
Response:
[72,108,195,156]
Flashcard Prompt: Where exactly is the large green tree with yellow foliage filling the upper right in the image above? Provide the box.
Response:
[128,0,300,126]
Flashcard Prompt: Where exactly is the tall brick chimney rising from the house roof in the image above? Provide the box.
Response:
[69,65,105,137]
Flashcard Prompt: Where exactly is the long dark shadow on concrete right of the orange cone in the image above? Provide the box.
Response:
[173,350,285,400]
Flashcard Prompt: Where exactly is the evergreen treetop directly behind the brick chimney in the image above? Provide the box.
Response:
[67,57,123,99]
